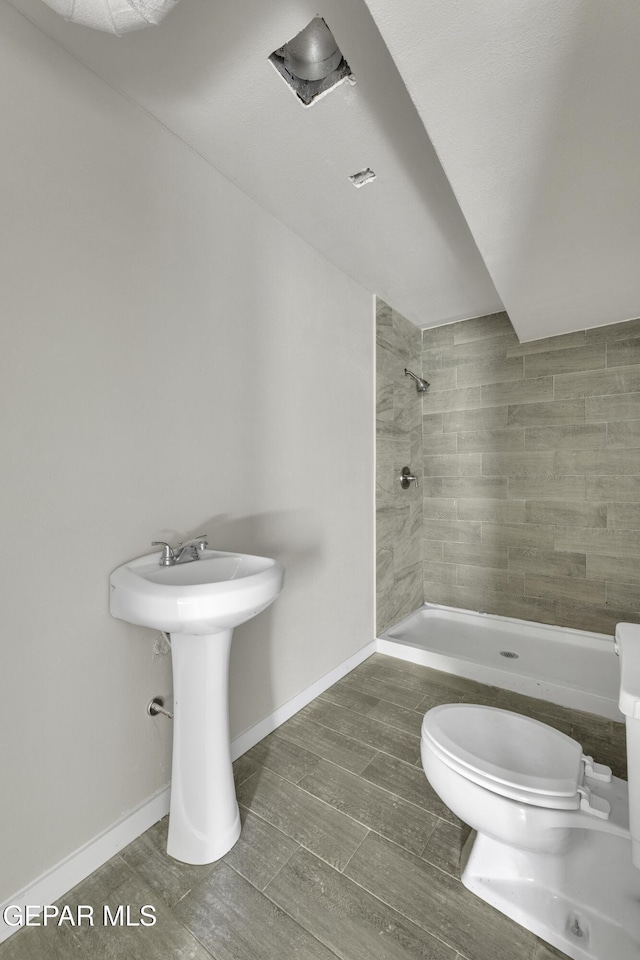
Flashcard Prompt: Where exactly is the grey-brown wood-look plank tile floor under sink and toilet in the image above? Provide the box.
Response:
[0,654,626,960]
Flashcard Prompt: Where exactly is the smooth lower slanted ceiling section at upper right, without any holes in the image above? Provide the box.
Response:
[367,0,640,340]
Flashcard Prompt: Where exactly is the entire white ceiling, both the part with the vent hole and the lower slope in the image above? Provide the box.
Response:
[5,0,640,340]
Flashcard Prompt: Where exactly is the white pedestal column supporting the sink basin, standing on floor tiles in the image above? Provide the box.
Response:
[167,630,240,863]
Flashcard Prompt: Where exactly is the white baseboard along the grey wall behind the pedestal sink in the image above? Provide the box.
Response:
[0,640,376,943]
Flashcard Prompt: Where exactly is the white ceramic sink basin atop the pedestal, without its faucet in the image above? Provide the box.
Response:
[111,550,284,636]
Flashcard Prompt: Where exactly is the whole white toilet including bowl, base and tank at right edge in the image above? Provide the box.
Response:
[421,623,640,960]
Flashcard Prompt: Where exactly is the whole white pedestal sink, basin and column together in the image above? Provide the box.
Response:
[110,549,284,863]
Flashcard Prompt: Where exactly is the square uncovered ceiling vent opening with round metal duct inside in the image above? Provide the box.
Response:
[269,17,355,107]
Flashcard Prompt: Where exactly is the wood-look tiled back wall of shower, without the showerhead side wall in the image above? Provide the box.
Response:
[422,313,640,633]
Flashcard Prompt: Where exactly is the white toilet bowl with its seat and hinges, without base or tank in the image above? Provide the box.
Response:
[421,703,629,853]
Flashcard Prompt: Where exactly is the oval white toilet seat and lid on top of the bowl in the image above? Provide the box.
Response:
[422,703,584,810]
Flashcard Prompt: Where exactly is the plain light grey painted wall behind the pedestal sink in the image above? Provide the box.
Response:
[0,3,374,901]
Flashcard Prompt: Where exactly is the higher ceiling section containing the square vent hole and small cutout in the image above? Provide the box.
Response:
[5,0,502,326]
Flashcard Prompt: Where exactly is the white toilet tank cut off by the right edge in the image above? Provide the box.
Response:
[616,623,640,869]
